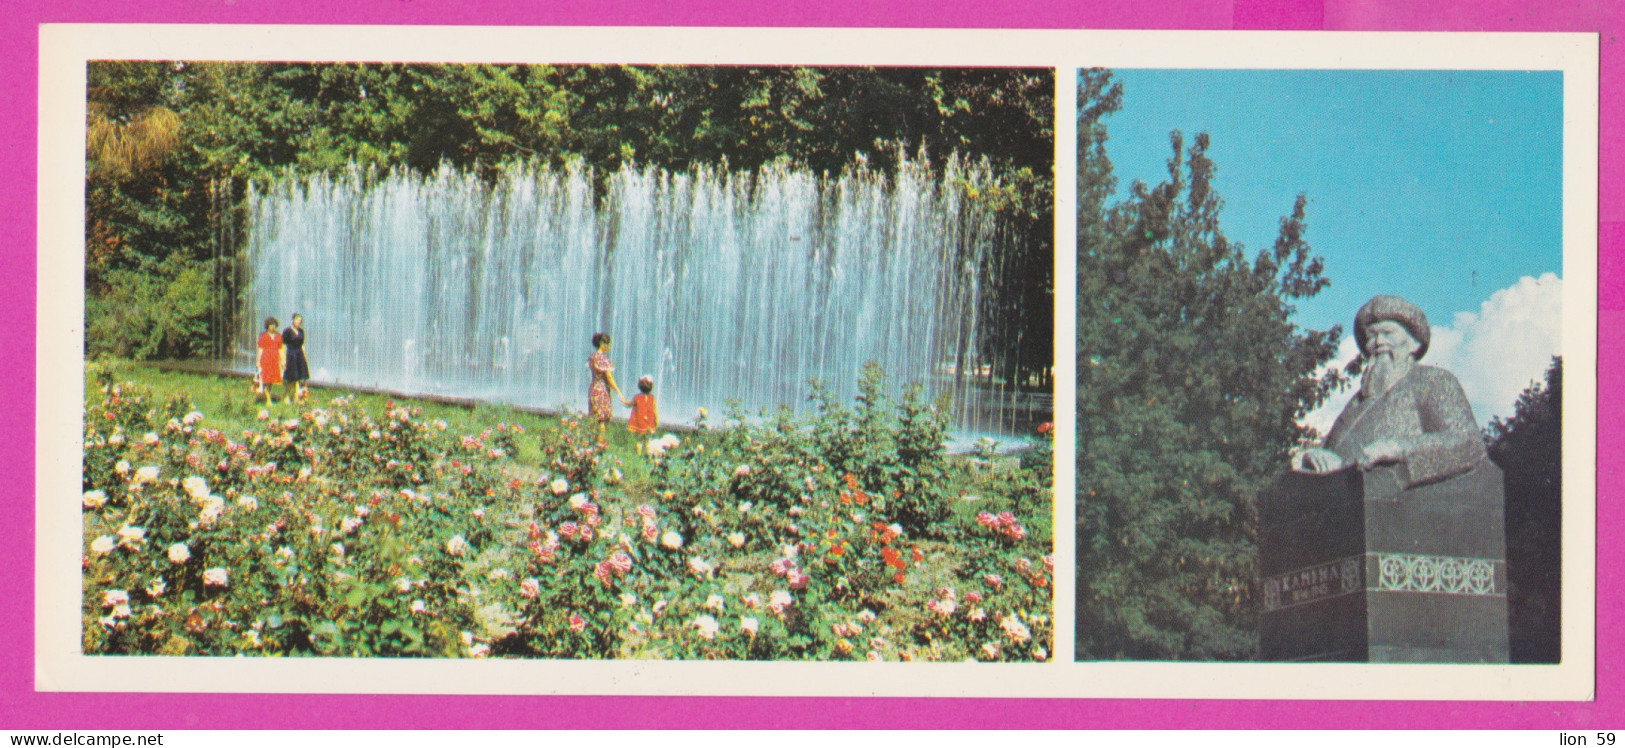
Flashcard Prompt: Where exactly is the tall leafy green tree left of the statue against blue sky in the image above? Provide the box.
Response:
[1076,70,1342,660]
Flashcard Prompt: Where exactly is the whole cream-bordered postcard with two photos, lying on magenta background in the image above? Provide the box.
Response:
[36,24,1597,699]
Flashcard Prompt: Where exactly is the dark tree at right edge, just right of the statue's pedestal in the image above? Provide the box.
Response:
[1485,356,1563,662]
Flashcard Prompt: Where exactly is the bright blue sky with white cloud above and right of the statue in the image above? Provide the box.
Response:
[1107,70,1563,421]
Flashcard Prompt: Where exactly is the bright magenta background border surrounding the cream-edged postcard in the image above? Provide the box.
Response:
[9,0,1625,730]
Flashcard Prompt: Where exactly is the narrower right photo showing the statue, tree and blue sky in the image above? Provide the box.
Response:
[1074,68,1560,663]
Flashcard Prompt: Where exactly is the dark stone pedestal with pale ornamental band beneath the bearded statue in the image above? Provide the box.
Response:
[1258,460,1508,662]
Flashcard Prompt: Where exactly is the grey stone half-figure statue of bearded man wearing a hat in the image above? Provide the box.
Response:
[1292,296,1485,486]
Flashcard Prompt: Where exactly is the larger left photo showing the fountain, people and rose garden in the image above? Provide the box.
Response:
[76,59,1056,668]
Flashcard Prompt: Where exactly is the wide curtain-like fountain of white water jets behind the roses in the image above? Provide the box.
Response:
[239,158,1040,433]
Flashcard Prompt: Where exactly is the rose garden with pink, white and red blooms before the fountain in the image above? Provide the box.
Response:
[81,364,1053,662]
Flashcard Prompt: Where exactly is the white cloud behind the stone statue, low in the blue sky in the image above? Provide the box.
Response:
[1303,273,1563,434]
